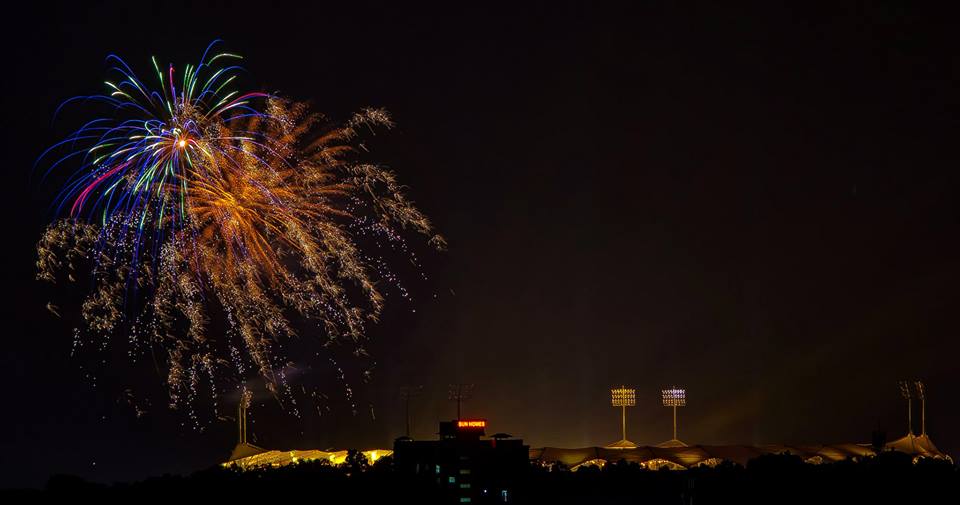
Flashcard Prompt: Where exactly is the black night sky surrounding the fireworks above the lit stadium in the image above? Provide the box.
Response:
[0,2,960,487]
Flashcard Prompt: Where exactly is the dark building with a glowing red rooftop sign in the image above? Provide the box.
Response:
[393,419,530,503]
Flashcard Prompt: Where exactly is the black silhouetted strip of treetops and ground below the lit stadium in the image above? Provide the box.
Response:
[0,453,960,504]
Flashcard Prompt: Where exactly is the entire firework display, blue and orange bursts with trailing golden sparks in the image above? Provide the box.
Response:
[37,42,444,414]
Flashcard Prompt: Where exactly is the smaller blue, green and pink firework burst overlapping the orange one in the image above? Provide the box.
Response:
[38,40,269,260]
